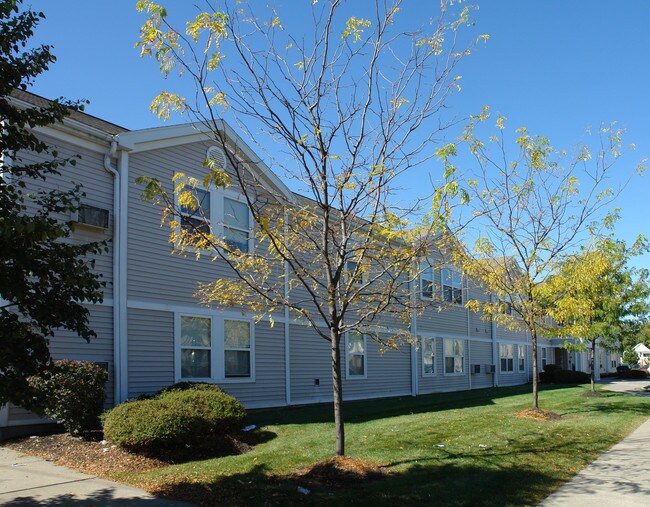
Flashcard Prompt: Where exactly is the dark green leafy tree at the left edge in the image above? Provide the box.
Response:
[0,0,106,405]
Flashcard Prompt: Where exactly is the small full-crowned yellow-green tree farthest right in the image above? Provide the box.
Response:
[544,237,650,392]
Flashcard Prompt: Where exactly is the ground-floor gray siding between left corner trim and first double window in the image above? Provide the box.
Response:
[128,308,174,398]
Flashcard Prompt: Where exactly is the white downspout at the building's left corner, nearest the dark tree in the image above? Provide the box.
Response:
[104,137,122,405]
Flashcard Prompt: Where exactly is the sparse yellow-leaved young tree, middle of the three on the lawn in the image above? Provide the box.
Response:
[444,109,642,410]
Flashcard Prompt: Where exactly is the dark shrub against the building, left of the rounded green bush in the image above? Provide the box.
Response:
[29,359,108,435]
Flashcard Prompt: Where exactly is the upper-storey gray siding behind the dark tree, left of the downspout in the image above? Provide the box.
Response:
[20,134,114,298]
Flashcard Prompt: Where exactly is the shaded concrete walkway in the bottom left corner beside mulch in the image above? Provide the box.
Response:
[0,447,190,507]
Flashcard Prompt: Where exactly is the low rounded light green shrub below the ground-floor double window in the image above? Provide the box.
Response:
[104,382,246,450]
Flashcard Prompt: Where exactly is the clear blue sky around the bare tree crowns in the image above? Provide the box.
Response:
[26,0,650,274]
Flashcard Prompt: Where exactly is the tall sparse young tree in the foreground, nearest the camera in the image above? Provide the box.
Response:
[137,0,486,455]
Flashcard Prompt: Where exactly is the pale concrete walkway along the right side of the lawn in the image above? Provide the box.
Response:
[541,379,650,507]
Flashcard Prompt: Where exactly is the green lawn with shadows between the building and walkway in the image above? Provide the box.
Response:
[120,386,650,506]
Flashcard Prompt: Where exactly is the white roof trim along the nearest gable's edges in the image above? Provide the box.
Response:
[117,120,295,202]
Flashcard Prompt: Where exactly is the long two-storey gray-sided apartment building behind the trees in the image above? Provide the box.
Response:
[0,92,616,438]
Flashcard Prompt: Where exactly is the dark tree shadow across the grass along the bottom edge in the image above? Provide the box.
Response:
[151,463,560,506]
